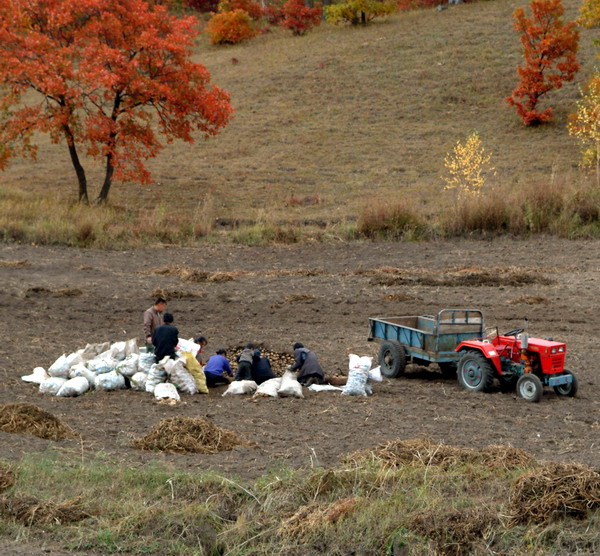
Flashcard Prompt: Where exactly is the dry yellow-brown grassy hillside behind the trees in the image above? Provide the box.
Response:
[0,0,598,242]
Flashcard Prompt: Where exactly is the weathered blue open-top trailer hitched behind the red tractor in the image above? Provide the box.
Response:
[368,309,485,378]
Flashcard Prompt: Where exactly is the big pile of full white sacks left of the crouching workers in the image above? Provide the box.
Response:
[21,338,204,400]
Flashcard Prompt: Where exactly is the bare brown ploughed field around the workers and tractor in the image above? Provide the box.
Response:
[0,239,600,477]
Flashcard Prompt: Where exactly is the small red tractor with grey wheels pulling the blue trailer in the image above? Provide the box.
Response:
[456,328,577,402]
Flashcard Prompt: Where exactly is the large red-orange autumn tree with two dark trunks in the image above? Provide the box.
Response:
[0,0,232,202]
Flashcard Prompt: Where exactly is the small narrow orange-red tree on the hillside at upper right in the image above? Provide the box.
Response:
[506,0,579,125]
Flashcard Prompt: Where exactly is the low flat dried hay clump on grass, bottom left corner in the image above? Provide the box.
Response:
[0,496,91,526]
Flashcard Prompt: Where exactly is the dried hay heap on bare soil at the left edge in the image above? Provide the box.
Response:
[0,403,77,440]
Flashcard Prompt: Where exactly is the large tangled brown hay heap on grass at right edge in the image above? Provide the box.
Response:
[509,463,600,525]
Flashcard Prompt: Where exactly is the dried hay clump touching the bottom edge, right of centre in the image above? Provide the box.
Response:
[412,508,500,555]
